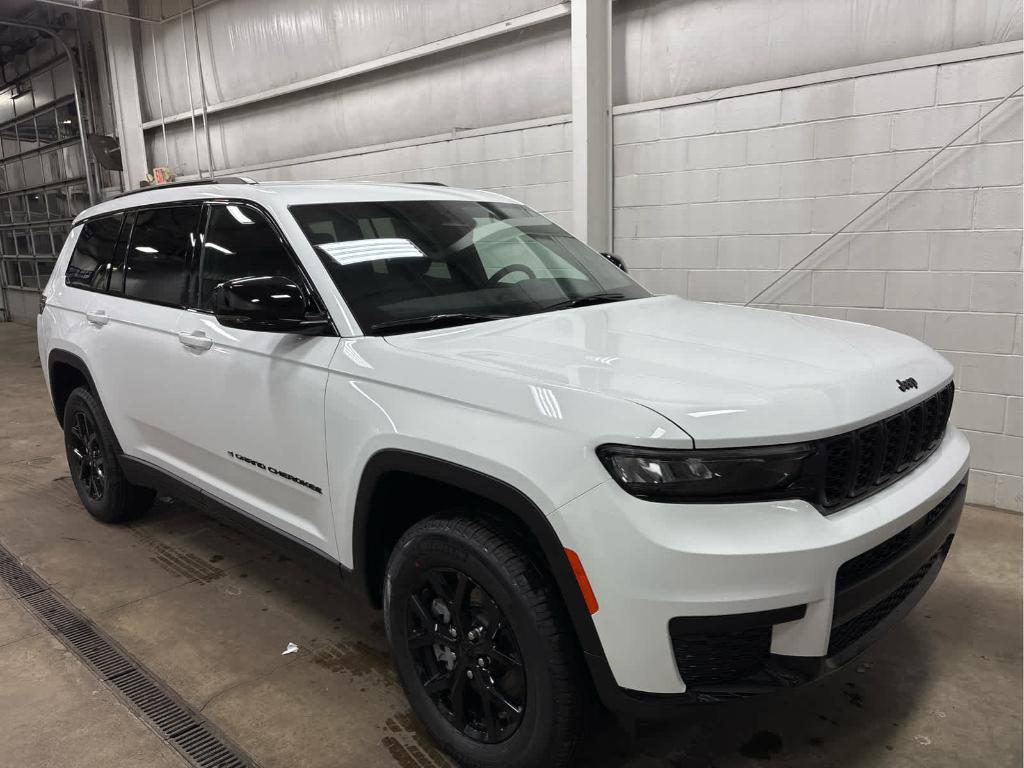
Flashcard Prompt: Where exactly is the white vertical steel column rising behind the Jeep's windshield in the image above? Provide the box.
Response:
[571,0,611,251]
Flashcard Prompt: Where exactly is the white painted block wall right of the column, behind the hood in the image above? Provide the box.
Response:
[614,53,1024,511]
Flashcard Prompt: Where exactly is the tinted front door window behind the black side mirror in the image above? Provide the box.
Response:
[199,205,303,309]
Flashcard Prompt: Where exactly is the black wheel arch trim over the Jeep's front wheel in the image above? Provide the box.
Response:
[352,449,614,697]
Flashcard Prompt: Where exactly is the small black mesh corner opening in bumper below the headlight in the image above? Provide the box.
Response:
[672,627,771,688]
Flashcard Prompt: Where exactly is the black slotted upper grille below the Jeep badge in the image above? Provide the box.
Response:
[819,384,953,514]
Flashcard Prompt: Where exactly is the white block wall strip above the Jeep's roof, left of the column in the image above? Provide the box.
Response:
[248,118,572,227]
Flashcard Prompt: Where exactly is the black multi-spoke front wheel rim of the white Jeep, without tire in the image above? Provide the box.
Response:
[407,568,526,743]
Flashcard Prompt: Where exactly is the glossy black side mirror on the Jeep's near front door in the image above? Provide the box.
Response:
[212,275,331,335]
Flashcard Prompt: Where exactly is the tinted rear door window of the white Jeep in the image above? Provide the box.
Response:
[125,206,200,306]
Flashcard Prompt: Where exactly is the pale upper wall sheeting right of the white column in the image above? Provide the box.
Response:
[612,0,1021,104]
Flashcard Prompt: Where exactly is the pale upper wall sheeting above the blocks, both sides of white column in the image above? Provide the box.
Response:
[138,0,1021,180]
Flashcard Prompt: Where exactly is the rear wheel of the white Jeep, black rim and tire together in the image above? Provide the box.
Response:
[63,387,157,523]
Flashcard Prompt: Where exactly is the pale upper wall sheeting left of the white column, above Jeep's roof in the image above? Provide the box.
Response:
[139,0,570,175]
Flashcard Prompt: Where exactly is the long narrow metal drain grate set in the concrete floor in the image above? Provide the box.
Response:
[0,546,255,768]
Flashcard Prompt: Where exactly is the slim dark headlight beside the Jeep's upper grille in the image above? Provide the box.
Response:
[597,443,816,502]
